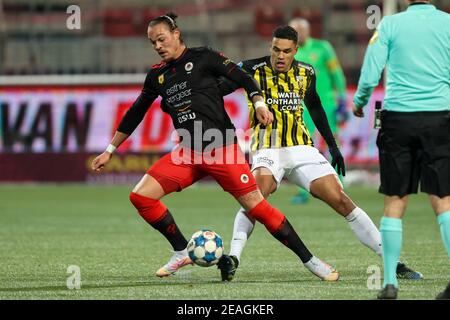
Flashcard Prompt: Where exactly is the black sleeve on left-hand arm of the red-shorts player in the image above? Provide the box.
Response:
[117,71,158,135]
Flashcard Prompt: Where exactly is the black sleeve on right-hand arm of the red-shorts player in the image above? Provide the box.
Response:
[204,50,262,99]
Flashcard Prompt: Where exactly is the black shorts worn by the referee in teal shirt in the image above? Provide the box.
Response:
[377,111,450,198]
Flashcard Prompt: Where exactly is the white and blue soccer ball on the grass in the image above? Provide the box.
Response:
[187,229,223,267]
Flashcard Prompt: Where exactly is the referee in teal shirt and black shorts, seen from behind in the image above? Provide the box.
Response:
[353,1,450,299]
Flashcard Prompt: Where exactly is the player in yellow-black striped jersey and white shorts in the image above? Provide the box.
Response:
[218,26,420,281]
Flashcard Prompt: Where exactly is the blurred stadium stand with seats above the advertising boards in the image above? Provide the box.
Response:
[0,0,450,84]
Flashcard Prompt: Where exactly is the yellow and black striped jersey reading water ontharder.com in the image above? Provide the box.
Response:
[238,56,315,150]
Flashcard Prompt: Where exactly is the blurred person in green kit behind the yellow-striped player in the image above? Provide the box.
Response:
[289,18,348,204]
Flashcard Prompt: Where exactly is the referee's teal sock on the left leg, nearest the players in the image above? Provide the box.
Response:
[380,217,402,287]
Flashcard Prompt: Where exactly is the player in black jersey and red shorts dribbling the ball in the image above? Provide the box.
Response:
[92,14,339,281]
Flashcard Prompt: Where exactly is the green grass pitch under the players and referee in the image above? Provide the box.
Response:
[0,184,448,299]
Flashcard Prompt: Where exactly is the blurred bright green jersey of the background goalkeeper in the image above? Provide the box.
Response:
[295,38,346,132]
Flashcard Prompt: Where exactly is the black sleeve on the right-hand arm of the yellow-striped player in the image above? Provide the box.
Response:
[304,73,337,148]
